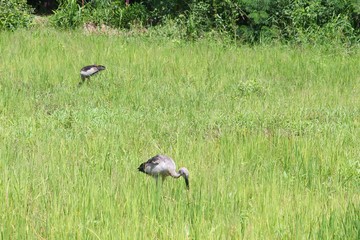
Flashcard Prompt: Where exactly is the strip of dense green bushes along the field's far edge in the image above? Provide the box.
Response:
[0,0,360,46]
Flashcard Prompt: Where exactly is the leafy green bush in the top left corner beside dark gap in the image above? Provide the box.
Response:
[0,0,33,31]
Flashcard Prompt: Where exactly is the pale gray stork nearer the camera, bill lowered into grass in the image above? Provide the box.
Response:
[138,155,189,189]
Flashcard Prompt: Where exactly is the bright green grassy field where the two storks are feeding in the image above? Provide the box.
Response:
[0,30,360,239]
